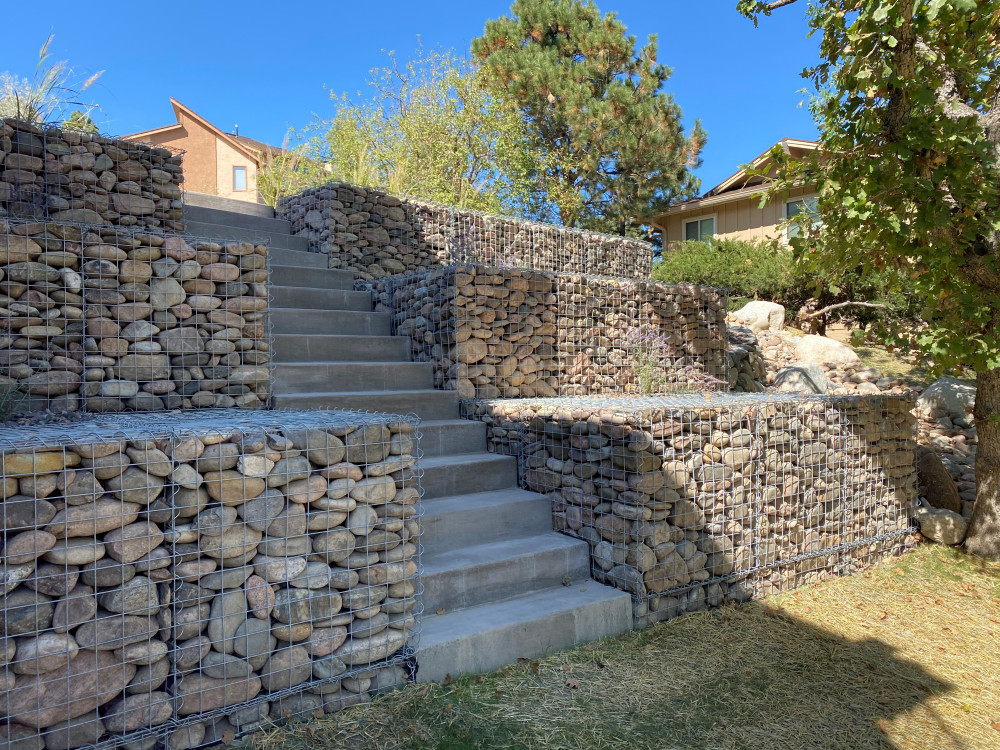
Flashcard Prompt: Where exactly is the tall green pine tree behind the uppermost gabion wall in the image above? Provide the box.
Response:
[472,0,705,234]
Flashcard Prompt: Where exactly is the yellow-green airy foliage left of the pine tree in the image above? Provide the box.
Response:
[300,49,536,213]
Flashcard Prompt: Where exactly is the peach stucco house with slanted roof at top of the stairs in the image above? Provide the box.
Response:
[125,97,282,203]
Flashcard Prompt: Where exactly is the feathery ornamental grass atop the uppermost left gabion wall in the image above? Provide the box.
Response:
[0,34,104,130]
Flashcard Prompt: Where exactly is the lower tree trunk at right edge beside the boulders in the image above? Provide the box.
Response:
[965,368,1000,560]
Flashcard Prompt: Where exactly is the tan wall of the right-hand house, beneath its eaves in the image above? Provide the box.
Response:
[662,188,815,247]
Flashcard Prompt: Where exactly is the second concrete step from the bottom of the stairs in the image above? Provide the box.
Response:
[420,531,590,613]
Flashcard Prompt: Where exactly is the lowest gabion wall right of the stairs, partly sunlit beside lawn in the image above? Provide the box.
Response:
[460,394,916,621]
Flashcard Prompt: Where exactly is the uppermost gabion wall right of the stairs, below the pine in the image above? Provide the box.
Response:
[276,183,653,281]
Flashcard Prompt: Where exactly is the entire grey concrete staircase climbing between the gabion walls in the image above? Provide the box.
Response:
[185,194,632,681]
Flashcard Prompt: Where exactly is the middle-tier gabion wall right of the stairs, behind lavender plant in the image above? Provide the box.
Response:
[374,265,728,399]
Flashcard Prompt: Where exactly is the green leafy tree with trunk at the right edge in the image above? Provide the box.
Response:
[738,0,1000,558]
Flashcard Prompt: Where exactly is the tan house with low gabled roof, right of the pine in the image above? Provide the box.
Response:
[651,138,817,249]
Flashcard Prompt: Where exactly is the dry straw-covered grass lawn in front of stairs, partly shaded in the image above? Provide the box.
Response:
[250,546,1000,750]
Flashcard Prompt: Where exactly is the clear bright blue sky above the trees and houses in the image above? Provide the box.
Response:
[0,0,817,190]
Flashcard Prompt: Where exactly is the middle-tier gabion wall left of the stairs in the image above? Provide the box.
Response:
[0,220,271,411]
